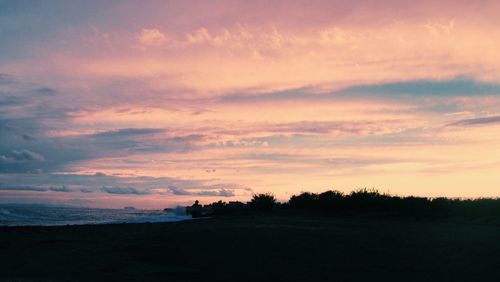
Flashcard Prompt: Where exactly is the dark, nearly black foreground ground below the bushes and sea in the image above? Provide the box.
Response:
[0,216,500,281]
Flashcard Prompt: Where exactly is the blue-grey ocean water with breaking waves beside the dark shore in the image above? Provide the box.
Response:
[0,204,191,226]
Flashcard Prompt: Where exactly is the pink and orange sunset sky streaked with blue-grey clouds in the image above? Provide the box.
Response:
[0,0,500,208]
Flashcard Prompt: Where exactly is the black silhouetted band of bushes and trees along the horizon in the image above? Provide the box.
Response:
[187,189,500,218]
